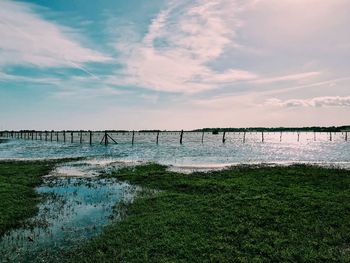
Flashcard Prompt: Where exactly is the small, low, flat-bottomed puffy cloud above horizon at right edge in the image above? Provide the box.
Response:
[265,96,350,108]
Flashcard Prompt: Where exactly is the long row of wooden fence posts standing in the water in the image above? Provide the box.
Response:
[0,130,348,145]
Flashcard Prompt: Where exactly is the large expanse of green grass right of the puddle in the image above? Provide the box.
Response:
[67,164,350,262]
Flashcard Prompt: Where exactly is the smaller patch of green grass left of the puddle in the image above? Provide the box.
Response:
[0,161,65,237]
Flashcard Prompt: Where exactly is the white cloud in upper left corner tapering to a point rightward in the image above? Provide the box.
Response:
[0,0,109,67]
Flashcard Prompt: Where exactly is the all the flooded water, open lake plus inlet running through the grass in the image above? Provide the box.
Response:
[0,132,350,262]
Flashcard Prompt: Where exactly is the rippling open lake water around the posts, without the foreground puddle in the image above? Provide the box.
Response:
[0,132,350,167]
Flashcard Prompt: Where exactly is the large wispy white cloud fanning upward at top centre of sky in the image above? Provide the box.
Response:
[113,0,257,93]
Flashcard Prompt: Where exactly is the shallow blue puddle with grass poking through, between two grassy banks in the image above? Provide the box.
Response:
[0,177,138,262]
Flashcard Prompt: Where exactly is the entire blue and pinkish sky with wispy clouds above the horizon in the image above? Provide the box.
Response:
[0,0,350,130]
